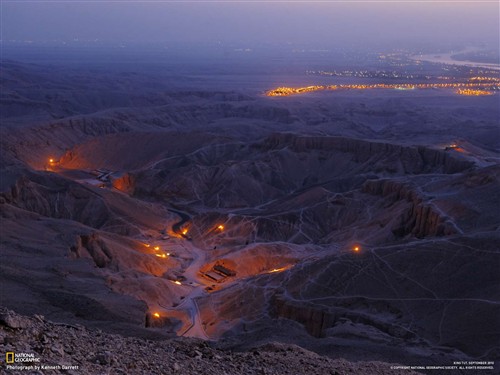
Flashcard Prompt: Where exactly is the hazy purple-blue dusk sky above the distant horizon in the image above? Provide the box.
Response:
[2,0,499,46]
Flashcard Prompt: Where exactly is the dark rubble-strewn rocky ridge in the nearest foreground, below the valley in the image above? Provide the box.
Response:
[0,308,418,375]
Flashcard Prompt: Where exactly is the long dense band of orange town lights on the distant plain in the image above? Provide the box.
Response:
[266,82,498,96]
